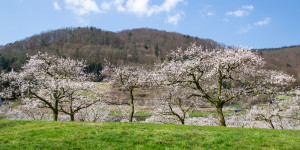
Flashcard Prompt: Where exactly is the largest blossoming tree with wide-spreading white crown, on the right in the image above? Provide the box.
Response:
[157,45,294,126]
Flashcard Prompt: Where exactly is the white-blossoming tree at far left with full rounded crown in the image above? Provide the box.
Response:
[0,53,96,121]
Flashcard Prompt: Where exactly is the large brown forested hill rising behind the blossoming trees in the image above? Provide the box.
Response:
[0,27,220,70]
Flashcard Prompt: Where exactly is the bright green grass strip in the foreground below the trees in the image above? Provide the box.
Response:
[0,120,300,150]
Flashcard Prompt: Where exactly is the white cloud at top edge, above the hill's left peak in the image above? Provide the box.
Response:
[64,0,101,15]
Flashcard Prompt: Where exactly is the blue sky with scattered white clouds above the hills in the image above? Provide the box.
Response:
[0,0,300,48]
